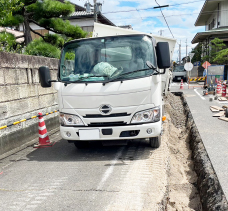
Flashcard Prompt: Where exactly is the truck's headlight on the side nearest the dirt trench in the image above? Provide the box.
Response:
[131,107,160,124]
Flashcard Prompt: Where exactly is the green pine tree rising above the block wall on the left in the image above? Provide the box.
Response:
[0,0,87,55]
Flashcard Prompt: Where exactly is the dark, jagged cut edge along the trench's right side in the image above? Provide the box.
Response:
[173,92,228,211]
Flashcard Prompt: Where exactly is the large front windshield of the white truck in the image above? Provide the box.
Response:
[60,35,157,82]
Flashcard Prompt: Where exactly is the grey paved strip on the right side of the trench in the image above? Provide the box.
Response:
[171,84,228,199]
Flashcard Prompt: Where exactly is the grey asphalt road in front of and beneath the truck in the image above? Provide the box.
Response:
[0,134,166,211]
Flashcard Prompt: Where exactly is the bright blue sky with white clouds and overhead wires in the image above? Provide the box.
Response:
[70,0,205,60]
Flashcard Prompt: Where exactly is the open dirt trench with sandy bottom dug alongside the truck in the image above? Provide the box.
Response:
[163,93,228,211]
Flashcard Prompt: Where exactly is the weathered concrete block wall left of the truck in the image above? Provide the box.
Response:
[0,52,58,156]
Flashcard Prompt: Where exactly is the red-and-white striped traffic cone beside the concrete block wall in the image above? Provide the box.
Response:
[34,113,54,148]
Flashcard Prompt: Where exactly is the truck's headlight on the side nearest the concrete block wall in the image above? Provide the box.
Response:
[59,113,84,126]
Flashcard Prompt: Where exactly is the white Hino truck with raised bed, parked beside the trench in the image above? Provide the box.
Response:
[39,24,176,148]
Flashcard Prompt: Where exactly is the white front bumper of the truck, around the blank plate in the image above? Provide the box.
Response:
[60,121,162,141]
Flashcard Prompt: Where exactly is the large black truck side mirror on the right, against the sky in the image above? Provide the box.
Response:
[156,42,170,69]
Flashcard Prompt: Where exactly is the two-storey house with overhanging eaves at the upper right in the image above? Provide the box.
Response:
[192,0,228,55]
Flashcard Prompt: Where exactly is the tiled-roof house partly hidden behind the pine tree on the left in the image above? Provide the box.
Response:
[20,0,115,39]
